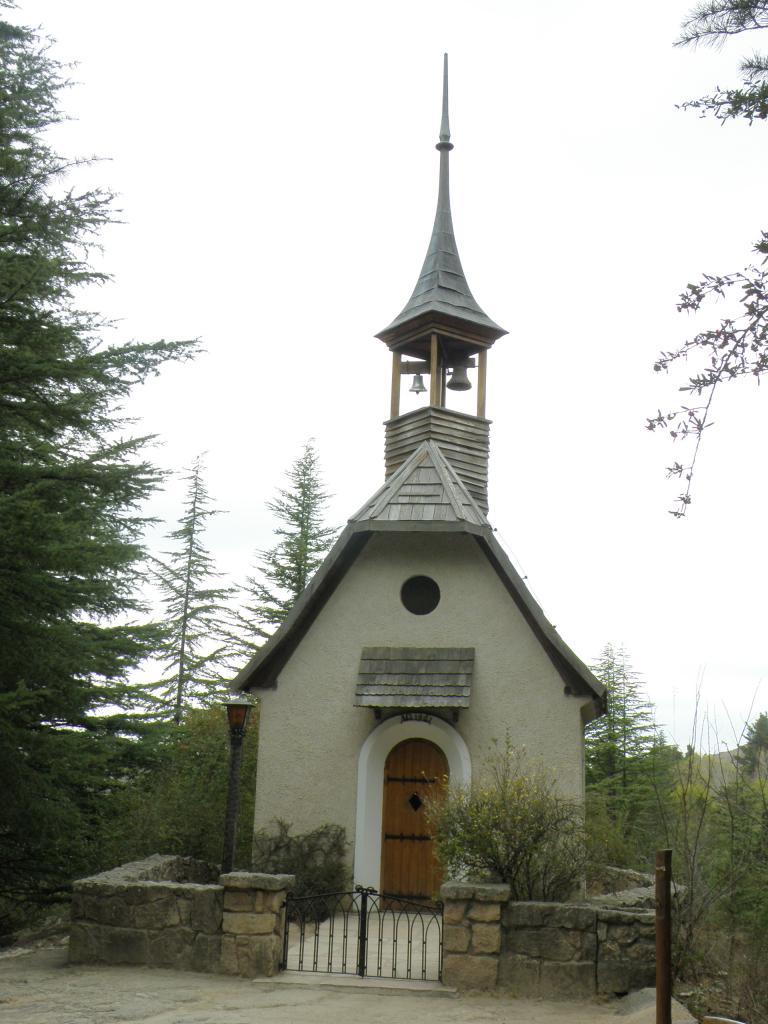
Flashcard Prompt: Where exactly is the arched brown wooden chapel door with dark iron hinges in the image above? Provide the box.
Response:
[381,739,449,900]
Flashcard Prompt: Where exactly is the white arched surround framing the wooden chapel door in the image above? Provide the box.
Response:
[354,715,472,889]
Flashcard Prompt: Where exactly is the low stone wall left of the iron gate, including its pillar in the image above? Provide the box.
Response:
[69,855,294,977]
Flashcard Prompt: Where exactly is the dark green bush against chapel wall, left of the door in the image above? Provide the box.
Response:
[253,819,349,896]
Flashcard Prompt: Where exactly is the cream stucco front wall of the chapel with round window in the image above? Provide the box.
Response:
[255,532,584,885]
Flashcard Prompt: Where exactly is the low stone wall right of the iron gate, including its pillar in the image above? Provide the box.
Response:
[441,883,655,998]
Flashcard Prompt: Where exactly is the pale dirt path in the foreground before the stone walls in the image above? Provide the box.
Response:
[0,946,690,1024]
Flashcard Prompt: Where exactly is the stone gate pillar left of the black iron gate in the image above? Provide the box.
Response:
[219,871,295,978]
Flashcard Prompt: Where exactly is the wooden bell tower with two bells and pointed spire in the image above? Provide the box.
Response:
[376,54,507,512]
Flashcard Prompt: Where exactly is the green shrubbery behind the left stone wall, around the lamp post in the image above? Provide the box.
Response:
[102,707,258,870]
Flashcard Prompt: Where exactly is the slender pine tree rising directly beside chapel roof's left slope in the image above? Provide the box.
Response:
[230,441,336,660]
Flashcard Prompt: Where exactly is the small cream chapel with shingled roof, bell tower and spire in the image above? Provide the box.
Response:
[234,58,604,899]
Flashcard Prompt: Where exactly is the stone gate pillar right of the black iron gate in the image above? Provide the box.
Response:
[440,882,509,991]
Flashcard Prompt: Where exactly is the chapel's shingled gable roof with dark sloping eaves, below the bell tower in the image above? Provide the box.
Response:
[232,441,605,721]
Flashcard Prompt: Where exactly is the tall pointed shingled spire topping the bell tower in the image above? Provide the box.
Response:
[377,53,507,343]
